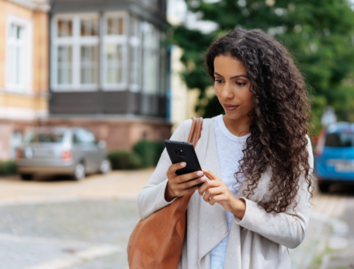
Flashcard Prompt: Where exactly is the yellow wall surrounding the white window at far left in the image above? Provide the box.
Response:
[0,0,49,114]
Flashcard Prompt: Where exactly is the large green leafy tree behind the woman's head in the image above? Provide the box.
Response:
[173,0,354,132]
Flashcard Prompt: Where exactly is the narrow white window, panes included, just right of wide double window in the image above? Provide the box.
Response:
[102,12,128,90]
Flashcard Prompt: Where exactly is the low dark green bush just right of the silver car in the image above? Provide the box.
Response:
[108,150,142,170]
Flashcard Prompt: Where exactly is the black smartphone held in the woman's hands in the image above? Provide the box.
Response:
[165,140,203,187]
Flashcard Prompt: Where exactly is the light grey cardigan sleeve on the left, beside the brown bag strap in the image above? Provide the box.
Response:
[137,119,192,219]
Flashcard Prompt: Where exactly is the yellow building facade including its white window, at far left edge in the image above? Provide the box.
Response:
[0,0,49,160]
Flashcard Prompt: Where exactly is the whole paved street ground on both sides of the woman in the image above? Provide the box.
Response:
[0,171,354,269]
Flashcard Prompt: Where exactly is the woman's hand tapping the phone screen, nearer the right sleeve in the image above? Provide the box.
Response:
[198,169,246,219]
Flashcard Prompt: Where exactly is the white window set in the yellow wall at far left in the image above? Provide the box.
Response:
[5,15,32,92]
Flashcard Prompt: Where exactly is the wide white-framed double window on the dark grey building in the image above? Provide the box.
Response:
[52,14,99,91]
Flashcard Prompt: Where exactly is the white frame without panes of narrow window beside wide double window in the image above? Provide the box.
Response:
[100,11,129,91]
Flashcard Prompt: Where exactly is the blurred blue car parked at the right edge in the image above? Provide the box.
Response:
[315,122,354,192]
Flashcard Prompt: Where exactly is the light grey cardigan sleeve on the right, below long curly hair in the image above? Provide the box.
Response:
[234,136,313,248]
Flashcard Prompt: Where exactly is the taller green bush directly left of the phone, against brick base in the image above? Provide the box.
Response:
[133,139,165,168]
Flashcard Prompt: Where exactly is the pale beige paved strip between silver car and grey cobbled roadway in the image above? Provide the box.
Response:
[0,168,154,205]
